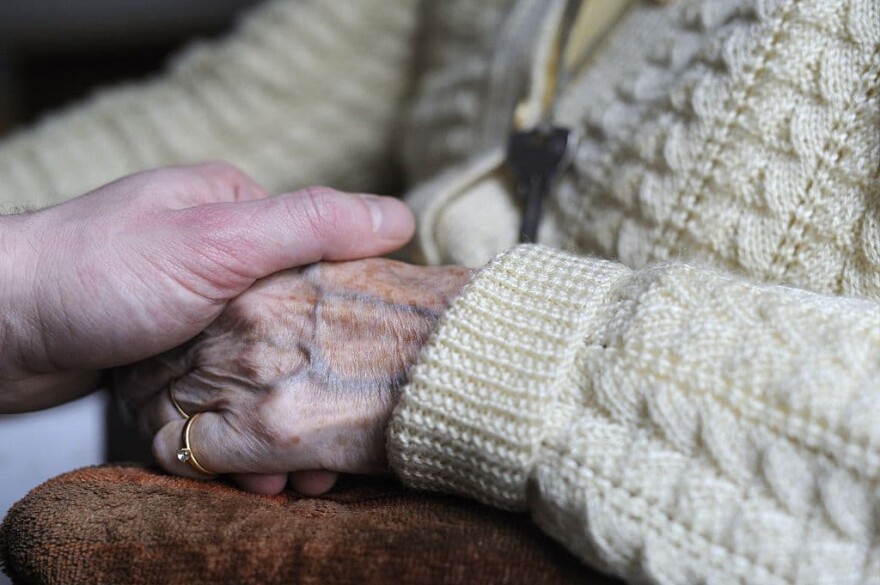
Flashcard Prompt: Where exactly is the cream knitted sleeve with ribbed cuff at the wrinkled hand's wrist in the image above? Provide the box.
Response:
[389,246,880,585]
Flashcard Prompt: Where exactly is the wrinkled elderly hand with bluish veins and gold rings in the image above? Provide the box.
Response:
[120,259,471,492]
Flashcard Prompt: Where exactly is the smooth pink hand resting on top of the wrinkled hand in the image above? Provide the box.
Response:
[0,163,413,413]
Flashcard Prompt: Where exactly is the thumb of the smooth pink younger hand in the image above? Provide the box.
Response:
[174,187,415,286]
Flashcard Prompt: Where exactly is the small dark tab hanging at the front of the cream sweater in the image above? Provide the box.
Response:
[507,126,579,243]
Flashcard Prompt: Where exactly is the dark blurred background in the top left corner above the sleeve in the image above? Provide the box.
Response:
[0,0,259,136]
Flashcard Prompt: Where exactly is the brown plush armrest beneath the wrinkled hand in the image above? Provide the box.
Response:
[0,466,611,585]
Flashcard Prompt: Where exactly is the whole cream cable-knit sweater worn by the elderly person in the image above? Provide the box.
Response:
[0,0,880,584]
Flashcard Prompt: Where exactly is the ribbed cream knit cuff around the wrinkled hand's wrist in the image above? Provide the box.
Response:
[388,246,630,510]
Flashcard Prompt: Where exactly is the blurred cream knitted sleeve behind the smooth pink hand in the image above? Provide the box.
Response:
[0,0,416,212]
